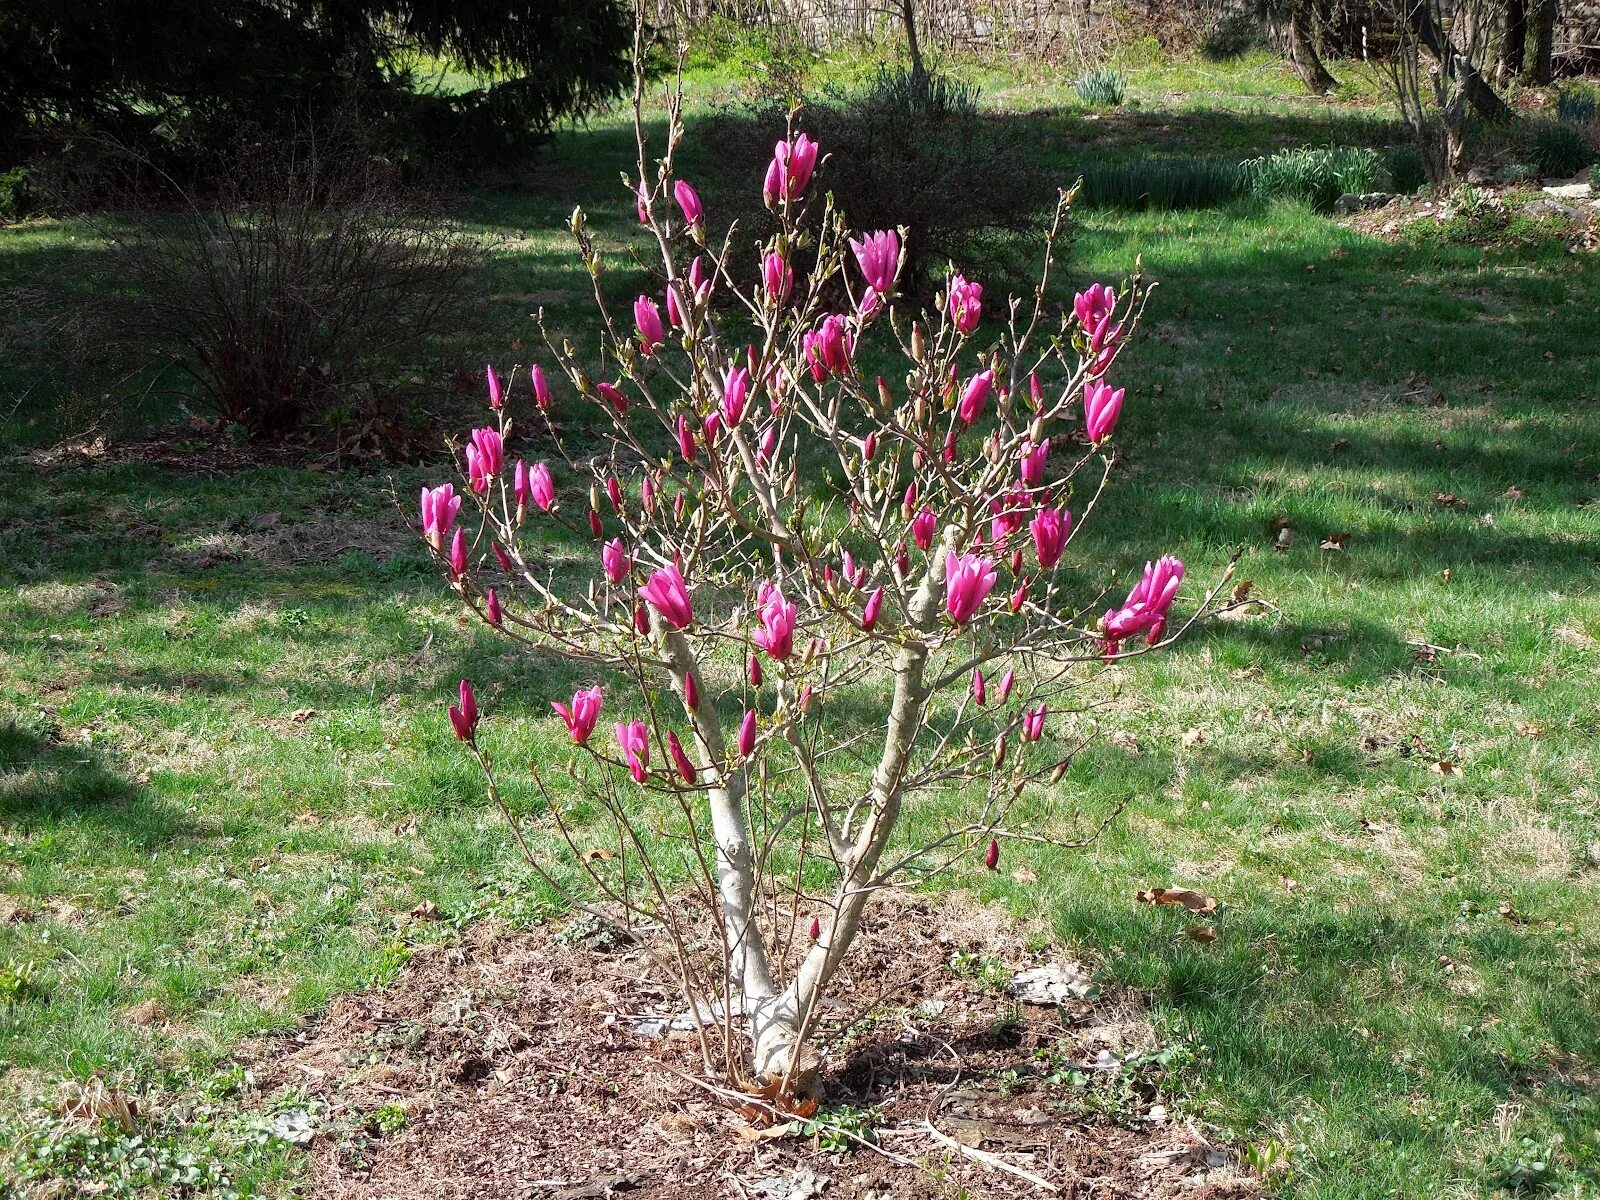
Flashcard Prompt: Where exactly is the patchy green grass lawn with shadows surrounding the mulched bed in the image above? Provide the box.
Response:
[0,51,1600,1200]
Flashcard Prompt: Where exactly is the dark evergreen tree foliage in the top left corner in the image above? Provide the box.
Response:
[0,0,630,177]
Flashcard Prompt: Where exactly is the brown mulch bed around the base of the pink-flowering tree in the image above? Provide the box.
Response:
[246,898,1261,1200]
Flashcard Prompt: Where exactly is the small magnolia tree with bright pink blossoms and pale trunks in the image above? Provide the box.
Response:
[406,35,1227,1102]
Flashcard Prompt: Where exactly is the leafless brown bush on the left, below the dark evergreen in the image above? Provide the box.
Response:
[107,123,480,438]
